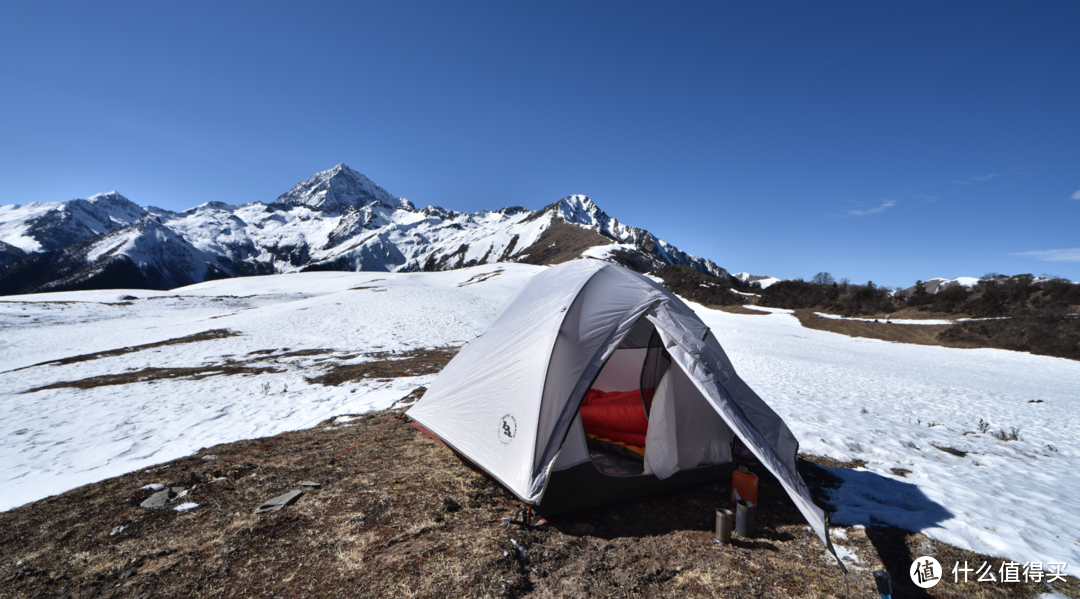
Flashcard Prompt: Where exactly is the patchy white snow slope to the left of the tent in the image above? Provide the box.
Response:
[0,264,540,509]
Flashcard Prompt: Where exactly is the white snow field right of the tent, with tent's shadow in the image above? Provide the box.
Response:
[694,305,1080,564]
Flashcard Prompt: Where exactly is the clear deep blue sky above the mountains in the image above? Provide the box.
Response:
[0,1,1080,286]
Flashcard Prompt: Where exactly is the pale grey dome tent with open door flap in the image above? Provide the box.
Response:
[408,259,828,544]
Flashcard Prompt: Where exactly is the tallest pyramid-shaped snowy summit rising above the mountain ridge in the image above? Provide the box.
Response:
[274,163,414,213]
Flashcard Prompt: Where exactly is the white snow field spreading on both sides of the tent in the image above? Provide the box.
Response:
[0,264,1080,574]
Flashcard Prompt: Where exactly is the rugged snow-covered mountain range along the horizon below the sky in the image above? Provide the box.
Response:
[0,164,728,295]
